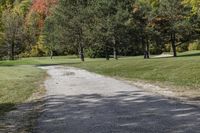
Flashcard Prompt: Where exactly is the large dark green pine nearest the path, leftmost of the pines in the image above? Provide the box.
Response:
[46,0,89,61]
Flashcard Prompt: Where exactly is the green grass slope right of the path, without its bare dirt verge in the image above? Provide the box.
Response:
[73,51,200,89]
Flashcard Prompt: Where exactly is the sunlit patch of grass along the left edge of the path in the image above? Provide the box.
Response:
[0,65,47,116]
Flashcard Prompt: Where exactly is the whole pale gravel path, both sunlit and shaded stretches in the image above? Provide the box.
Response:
[35,66,200,133]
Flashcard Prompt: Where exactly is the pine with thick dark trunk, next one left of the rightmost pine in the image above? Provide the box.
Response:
[131,0,159,59]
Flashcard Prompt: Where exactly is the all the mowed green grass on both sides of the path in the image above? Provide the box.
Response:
[0,51,200,115]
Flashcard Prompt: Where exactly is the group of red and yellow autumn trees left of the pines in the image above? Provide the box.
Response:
[0,0,57,60]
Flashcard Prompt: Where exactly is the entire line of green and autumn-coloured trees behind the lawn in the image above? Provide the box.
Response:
[0,0,200,61]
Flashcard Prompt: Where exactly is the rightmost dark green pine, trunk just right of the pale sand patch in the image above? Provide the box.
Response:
[156,0,191,57]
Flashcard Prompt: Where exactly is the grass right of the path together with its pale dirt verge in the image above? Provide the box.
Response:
[70,51,200,100]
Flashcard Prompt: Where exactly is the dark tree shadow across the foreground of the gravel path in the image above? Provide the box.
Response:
[34,91,200,133]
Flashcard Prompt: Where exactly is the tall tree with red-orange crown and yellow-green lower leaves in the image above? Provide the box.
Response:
[21,0,58,56]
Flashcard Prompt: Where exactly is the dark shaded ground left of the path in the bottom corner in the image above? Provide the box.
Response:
[0,100,43,133]
